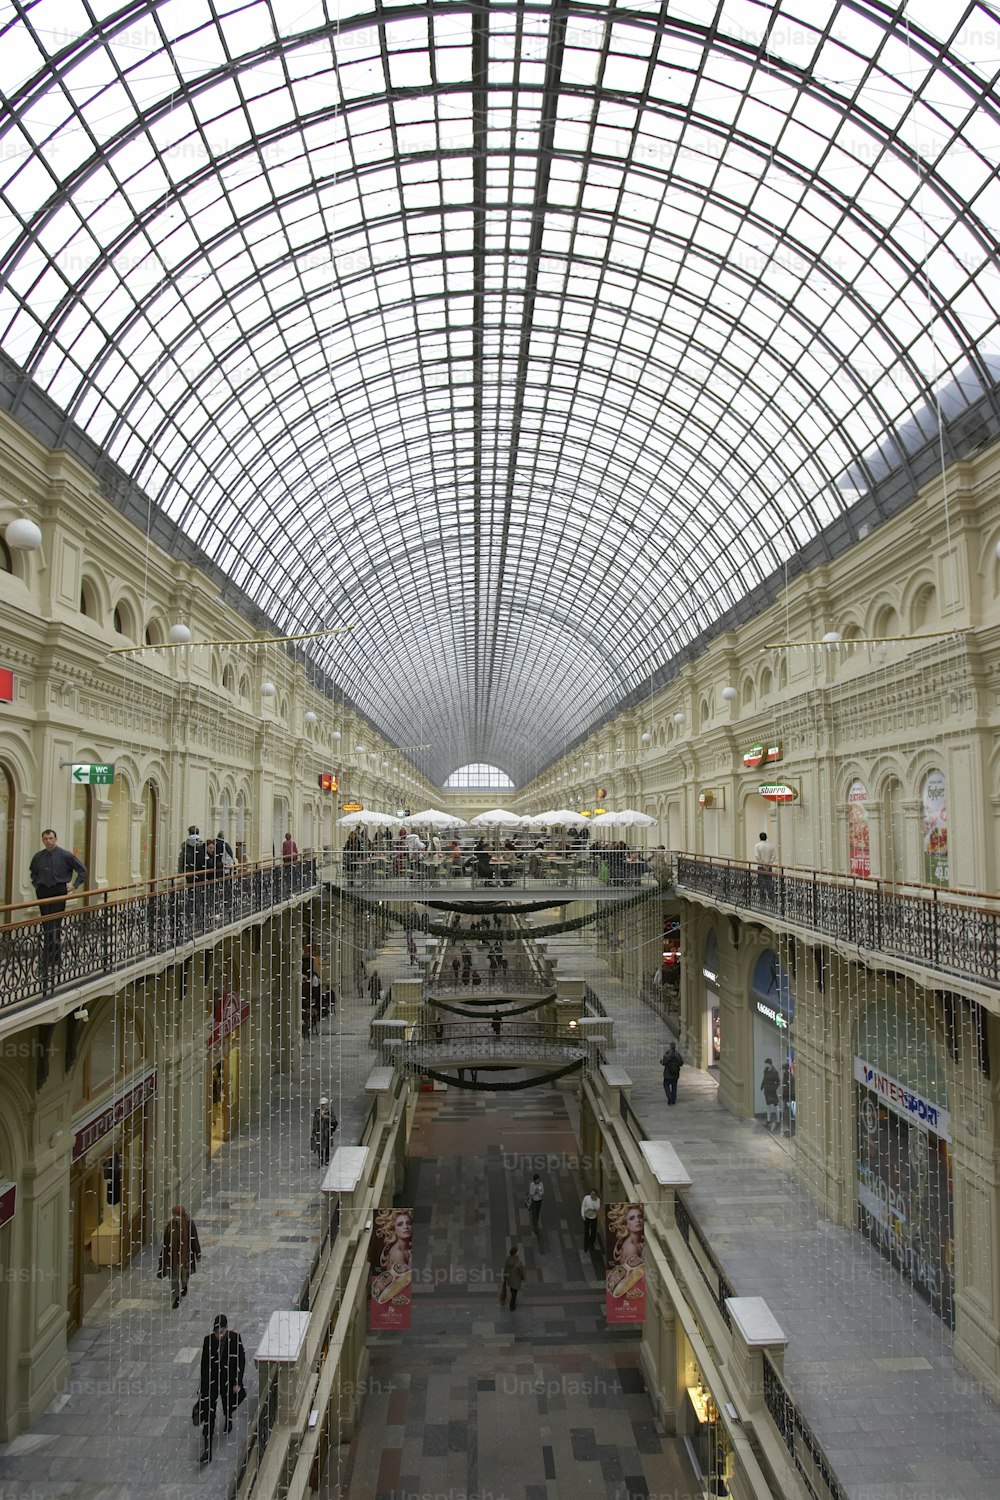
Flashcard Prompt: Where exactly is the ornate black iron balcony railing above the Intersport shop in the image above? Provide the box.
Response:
[676,854,1000,986]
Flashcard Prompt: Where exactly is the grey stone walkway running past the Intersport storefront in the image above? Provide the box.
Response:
[549,938,1000,1500]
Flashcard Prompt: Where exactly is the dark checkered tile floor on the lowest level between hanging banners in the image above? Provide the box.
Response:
[328,1089,702,1500]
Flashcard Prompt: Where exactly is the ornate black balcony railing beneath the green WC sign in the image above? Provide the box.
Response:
[0,857,318,1010]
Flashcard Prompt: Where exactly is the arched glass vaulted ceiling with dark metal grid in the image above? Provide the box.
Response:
[0,0,1000,783]
